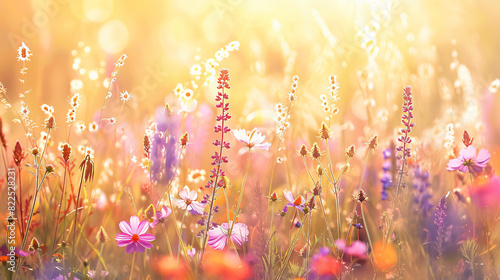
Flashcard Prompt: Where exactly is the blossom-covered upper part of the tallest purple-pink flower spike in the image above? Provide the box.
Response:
[206,69,231,188]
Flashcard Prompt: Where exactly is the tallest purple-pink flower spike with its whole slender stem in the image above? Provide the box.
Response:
[200,69,231,263]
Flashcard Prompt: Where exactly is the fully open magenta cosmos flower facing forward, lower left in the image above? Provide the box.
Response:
[115,216,156,254]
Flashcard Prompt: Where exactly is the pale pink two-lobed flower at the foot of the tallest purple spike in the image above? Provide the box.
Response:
[208,223,250,250]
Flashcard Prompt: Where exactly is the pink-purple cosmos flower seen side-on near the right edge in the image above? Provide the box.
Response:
[446,145,490,173]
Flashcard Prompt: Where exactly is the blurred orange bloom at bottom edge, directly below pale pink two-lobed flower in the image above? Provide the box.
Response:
[203,251,252,280]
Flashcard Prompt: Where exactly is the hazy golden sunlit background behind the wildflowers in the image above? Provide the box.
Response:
[0,0,500,274]
